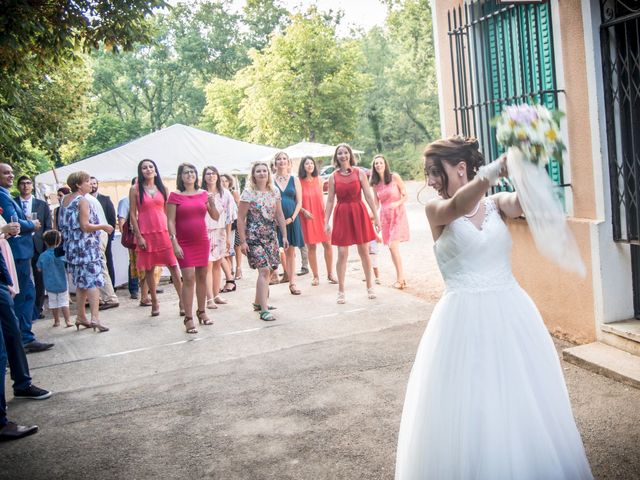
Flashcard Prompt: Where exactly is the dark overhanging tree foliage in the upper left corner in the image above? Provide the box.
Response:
[0,0,165,173]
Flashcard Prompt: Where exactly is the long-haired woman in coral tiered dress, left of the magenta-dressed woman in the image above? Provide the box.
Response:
[129,159,182,317]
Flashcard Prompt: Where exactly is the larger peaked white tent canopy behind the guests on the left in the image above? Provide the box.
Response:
[36,124,278,187]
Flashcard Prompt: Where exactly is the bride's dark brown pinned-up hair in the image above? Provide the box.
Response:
[422,135,485,190]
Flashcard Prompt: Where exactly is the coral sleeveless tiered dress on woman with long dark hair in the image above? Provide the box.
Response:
[136,192,178,271]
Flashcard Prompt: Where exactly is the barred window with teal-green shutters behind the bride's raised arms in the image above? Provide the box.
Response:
[448,0,568,193]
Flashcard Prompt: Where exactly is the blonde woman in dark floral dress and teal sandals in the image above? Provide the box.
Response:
[238,162,289,321]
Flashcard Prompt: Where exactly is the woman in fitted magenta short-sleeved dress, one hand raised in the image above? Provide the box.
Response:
[167,163,220,333]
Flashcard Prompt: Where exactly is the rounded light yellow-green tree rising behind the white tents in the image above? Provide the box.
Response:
[224,10,368,144]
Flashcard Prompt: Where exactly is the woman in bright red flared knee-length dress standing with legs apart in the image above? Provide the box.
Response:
[324,143,380,304]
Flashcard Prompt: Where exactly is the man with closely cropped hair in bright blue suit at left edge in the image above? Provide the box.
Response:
[0,163,53,353]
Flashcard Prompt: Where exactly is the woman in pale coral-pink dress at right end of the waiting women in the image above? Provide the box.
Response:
[370,155,409,289]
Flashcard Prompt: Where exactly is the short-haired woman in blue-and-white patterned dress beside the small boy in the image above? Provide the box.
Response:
[60,172,113,332]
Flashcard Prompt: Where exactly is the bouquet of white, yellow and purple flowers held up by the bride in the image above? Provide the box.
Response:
[493,103,565,166]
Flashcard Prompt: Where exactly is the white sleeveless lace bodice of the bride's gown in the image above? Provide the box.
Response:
[434,198,516,292]
